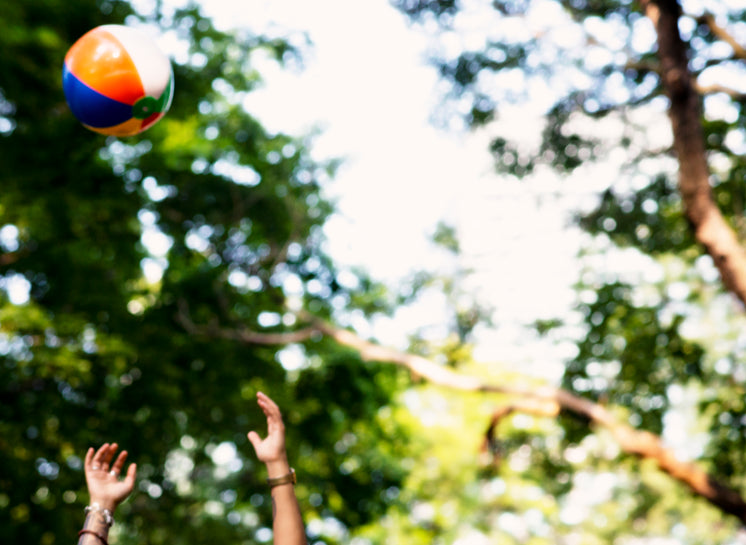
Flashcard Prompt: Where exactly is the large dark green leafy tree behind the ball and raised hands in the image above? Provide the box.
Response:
[0,0,402,544]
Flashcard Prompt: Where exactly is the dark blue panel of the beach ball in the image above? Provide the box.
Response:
[62,64,132,128]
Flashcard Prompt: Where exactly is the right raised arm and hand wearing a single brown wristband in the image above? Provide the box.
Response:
[248,392,306,545]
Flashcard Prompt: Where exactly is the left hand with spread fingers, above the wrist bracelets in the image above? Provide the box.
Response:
[84,443,137,511]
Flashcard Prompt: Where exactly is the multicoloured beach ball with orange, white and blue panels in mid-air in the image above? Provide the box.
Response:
[62,25,174,136]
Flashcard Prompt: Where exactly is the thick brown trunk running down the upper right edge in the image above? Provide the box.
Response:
[640,0,746,304]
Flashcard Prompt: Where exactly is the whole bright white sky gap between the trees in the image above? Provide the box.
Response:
[193,0,592,372]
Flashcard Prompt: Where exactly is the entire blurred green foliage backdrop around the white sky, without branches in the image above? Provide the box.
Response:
[0,0,746,545]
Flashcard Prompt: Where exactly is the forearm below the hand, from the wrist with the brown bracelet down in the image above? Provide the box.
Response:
[267,458,306,545]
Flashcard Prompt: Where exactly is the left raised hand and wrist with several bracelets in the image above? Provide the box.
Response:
[78,443,137,545]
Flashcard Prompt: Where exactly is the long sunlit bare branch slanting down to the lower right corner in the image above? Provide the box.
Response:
[177,308,746,524]
